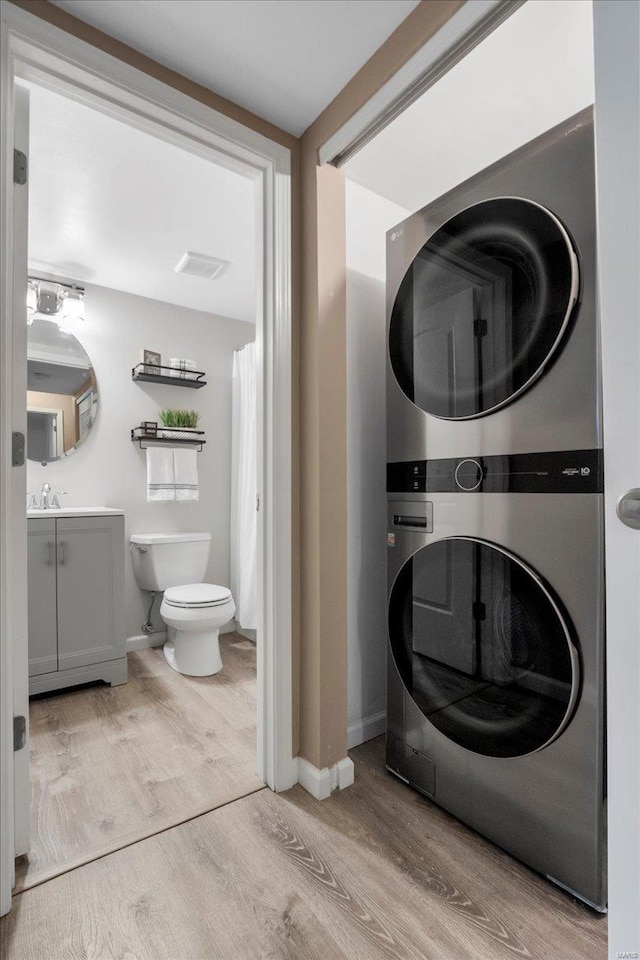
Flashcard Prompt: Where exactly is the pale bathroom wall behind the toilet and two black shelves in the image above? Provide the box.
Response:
[27,280,255,637]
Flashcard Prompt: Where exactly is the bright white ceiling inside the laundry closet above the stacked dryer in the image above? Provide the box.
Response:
[344,0,594,211]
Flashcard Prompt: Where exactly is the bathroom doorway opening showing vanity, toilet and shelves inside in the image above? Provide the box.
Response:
[16,77,264,891]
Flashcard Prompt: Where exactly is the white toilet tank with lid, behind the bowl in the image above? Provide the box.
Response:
[129,533,211,591]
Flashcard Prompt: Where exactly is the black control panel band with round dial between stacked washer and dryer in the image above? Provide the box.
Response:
[387,450,604,493]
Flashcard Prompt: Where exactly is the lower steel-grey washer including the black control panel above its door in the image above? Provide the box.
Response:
[387,449,606,909]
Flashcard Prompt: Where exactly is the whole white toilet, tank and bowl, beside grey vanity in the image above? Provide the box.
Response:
[130,533,236,677]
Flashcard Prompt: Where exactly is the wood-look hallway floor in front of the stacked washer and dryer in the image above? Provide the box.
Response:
[0,741,606,960]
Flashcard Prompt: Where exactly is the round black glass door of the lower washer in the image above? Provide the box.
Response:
[389,537,579,757]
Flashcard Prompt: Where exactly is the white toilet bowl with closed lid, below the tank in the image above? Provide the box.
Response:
[160,583,236,677]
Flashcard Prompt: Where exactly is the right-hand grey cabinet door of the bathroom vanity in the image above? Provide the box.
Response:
[56,517,125,670]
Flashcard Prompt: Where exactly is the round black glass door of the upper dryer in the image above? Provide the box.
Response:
[389,197,579,420]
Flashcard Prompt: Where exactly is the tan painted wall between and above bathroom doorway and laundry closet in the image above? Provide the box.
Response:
[12,0,464,767]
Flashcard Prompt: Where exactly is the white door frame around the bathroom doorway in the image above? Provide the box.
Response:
[0,3,297,914]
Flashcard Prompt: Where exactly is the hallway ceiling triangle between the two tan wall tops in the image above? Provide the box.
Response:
[53,0,418,136]
